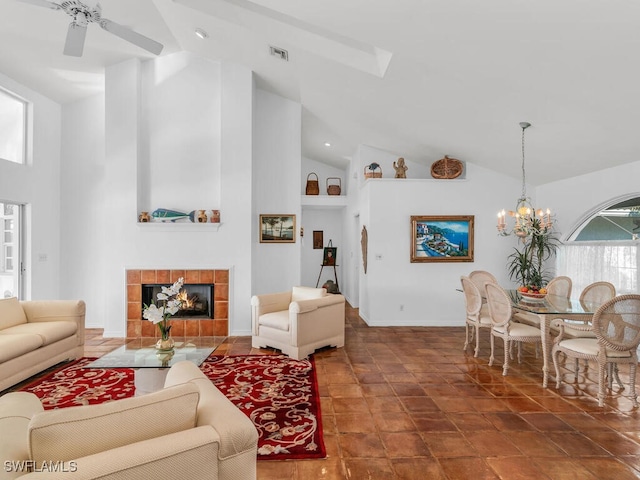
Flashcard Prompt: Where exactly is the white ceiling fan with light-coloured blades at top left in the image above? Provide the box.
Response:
[18,0,163,57]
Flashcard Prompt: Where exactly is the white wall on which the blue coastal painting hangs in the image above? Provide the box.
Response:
[358,147,519,326]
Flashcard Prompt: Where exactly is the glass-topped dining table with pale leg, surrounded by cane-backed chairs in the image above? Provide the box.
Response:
[505,290,600,388]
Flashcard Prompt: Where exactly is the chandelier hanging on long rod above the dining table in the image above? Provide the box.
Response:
[498,122,553,239]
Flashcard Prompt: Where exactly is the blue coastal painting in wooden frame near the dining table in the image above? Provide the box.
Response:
[411,215,473,263]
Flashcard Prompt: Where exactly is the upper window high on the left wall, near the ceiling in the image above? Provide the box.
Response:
[0,89,27,163]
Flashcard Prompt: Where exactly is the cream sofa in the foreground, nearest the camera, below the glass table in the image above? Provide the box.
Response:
[0,361,258,480]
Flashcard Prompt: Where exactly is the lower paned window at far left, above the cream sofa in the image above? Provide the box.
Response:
[0,203,22,298]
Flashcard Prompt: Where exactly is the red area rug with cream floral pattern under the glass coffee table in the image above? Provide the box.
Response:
[20,355,326,460]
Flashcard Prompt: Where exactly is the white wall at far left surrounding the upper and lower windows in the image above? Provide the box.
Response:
[0,74,61,299]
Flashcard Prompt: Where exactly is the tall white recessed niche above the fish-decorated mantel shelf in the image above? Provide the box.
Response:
[138,53,221,213]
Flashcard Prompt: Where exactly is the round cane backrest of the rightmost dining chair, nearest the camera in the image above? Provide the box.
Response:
[593,294,640,352]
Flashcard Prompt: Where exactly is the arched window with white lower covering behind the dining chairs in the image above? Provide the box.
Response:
[556,194,640,294]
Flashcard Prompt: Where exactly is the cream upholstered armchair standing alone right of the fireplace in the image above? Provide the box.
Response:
[251,287,345,360]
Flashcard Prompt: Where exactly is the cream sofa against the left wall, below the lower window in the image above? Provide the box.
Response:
[0,298,85,391]
